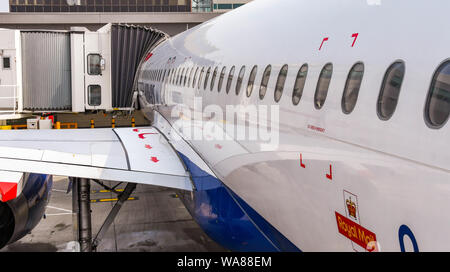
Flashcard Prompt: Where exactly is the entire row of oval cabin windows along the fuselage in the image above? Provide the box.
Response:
[145,60,450,128]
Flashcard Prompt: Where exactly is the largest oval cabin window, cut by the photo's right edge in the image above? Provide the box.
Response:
[425,61,450,128]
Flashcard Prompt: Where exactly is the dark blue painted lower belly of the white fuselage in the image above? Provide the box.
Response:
[178,152,300,252]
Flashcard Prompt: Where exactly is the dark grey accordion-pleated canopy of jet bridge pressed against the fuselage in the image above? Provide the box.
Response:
[111,24,166,108]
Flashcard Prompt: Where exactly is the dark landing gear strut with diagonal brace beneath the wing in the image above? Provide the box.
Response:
[70,178,136,252]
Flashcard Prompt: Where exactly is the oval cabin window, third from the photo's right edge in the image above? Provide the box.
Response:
[341,62,364,114]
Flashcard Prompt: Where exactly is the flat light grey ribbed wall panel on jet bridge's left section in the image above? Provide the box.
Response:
[21,32,72,111]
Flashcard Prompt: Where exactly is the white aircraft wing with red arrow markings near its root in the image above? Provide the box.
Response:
[0,127,192,201]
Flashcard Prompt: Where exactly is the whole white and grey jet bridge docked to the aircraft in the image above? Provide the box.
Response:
[0,24,168,115]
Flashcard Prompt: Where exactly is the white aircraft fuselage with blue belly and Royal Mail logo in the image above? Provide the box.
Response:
[137,0,450,251]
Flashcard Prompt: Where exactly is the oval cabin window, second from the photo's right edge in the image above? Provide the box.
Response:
[377,61,405,120]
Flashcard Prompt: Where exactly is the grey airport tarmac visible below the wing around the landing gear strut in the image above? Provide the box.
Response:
[0,176,226,252]
